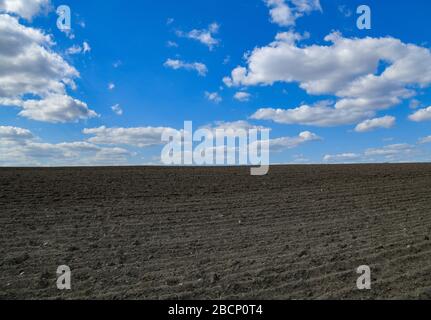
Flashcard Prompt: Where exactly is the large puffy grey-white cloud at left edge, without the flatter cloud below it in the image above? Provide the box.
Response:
[0,15,73,97]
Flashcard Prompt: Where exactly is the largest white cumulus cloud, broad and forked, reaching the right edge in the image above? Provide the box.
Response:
[224,32,431,126]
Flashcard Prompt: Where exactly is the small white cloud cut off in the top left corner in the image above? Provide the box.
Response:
[0,0,51,20]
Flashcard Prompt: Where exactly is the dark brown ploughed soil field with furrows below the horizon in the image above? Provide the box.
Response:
[0,164,431,299]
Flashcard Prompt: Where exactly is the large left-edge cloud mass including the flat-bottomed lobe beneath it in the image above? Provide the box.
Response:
[0,14,96,122]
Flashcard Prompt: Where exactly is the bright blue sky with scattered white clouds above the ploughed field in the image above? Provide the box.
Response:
[0,0,431,165]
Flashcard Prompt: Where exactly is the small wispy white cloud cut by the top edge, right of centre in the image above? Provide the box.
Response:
[264,0,322,27]
